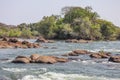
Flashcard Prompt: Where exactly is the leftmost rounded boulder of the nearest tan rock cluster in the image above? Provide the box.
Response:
[12,56,31,63]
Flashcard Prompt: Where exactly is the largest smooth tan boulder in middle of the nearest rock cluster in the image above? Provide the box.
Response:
[35,56,57,64]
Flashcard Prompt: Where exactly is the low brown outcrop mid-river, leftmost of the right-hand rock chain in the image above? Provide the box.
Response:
[62,49,89,56]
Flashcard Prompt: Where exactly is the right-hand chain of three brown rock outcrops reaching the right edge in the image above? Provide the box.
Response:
[62,50,120,63]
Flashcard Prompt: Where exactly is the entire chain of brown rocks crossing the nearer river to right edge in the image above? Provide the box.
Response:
[12,50,120,64]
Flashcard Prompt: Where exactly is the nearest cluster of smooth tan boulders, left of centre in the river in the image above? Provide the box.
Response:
[12,54,68,64]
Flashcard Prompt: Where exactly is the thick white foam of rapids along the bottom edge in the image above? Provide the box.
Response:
[18,72,120,80]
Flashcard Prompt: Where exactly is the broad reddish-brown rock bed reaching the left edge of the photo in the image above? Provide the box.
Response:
[0,38,40,48]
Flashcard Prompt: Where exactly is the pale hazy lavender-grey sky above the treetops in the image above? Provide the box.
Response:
[0,0,120,26]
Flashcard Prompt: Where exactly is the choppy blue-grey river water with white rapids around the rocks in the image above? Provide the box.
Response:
[0,40,120,80]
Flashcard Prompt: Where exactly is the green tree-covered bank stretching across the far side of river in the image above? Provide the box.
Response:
[0,6,120,40]
